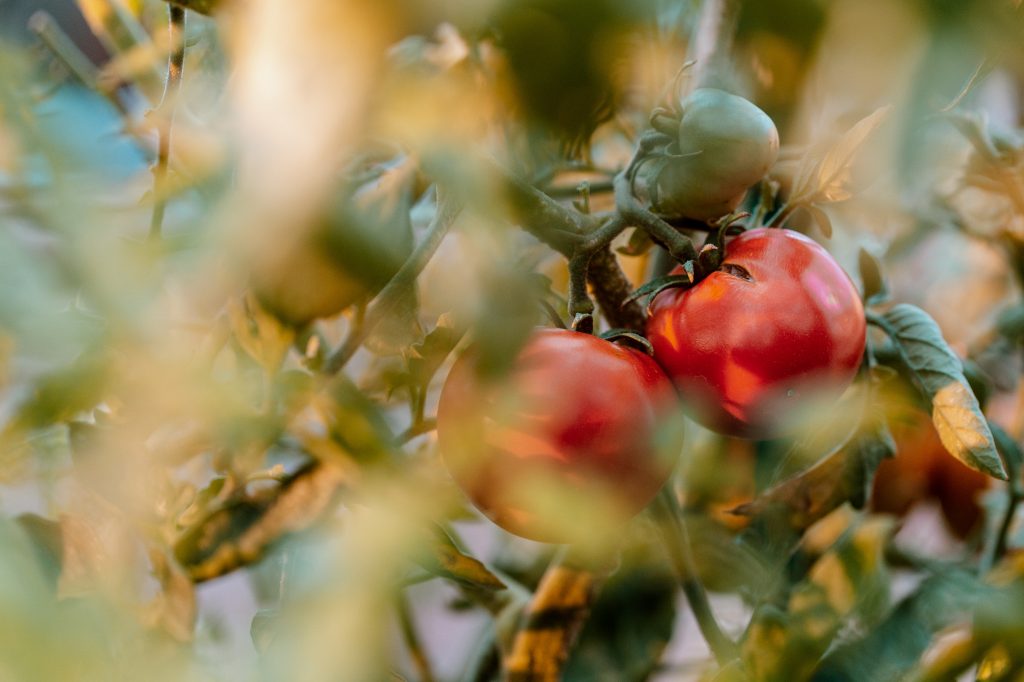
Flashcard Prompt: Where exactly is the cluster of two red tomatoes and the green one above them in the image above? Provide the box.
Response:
[437,89,865,542]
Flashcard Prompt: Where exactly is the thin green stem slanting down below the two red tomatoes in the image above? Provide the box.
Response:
[654,487,737,666]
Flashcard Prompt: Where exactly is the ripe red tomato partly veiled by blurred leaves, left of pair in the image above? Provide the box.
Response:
[437,329,683,542]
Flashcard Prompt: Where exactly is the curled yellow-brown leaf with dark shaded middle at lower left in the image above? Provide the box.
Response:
[174,464,344,583]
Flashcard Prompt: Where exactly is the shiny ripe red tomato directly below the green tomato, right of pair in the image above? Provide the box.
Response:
[647,227,865,438]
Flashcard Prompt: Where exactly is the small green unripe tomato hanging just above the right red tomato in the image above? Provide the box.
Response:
[638,88,778,221]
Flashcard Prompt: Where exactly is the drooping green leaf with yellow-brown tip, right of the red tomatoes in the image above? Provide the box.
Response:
[881,303,1007,480]
